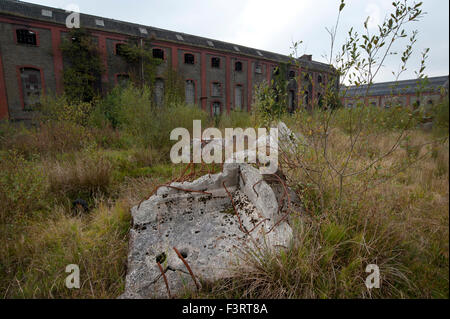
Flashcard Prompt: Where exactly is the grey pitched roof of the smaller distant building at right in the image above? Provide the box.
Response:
[341,75,448,97]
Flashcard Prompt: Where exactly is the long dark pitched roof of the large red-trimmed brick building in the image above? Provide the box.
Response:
[0,0,330,71]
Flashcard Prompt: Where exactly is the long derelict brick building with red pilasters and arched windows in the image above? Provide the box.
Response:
[0,0,338,120]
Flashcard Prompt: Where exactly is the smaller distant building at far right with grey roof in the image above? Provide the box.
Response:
[340,76,448,108]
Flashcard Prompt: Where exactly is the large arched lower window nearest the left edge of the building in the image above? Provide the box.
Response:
[20,68,42,111]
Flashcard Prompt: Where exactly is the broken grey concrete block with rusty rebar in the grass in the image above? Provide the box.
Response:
[120,164,298,298]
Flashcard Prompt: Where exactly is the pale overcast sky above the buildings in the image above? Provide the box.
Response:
[27,0,449,82]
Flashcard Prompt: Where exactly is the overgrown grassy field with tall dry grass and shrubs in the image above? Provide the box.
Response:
[0,88,449,298]
